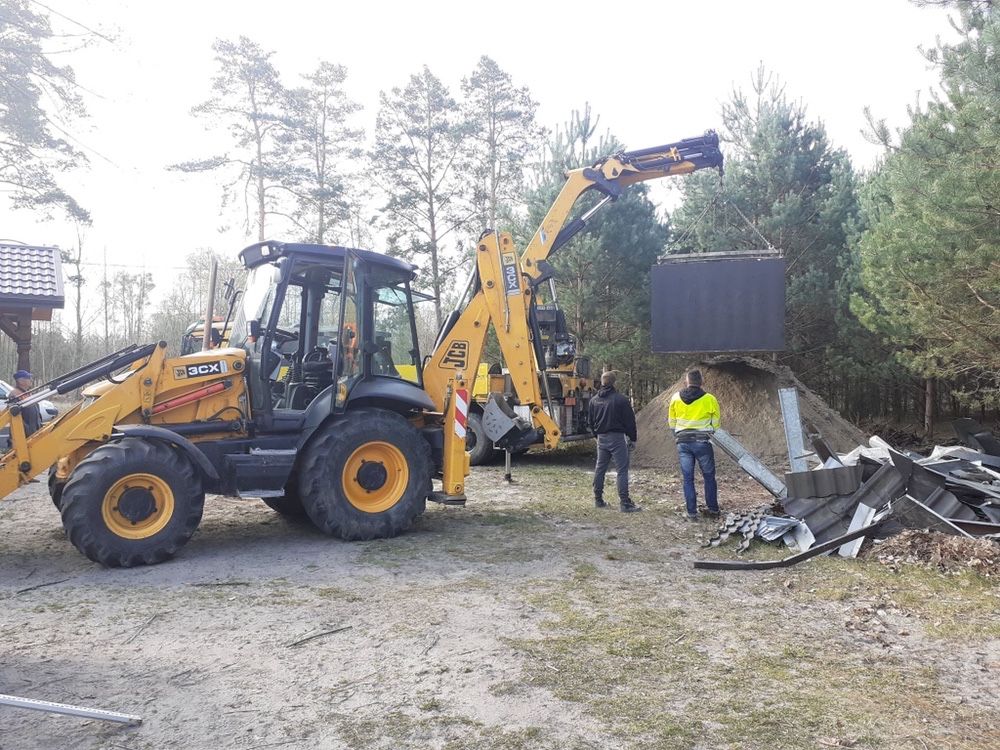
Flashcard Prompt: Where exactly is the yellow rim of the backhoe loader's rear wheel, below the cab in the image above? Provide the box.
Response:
[341,441,410,513]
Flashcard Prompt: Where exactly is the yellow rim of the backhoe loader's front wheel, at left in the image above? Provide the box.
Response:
[101,474,174,539]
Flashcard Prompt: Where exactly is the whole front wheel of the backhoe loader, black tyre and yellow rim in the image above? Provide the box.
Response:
[61,438,205,568]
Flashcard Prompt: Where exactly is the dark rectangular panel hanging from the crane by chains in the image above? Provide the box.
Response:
[650,255,785,353]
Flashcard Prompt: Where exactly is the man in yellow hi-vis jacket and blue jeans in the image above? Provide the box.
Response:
[668,370,720,521]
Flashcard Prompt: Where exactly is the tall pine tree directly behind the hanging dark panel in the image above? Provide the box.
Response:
[671,67,884,414]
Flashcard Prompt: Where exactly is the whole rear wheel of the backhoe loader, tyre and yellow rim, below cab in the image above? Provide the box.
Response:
[298,409,431,541]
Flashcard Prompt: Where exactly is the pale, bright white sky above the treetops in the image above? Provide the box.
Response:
[0,0,950,288]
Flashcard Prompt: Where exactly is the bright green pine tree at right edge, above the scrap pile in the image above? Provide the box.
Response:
[854,2,1000,412]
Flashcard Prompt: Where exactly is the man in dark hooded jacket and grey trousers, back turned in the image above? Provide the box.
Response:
[587,372,642,513]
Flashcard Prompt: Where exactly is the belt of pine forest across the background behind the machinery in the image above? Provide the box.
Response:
[0,0,1000,434]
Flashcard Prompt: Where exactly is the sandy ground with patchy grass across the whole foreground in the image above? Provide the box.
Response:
[0,451,1000,750]
